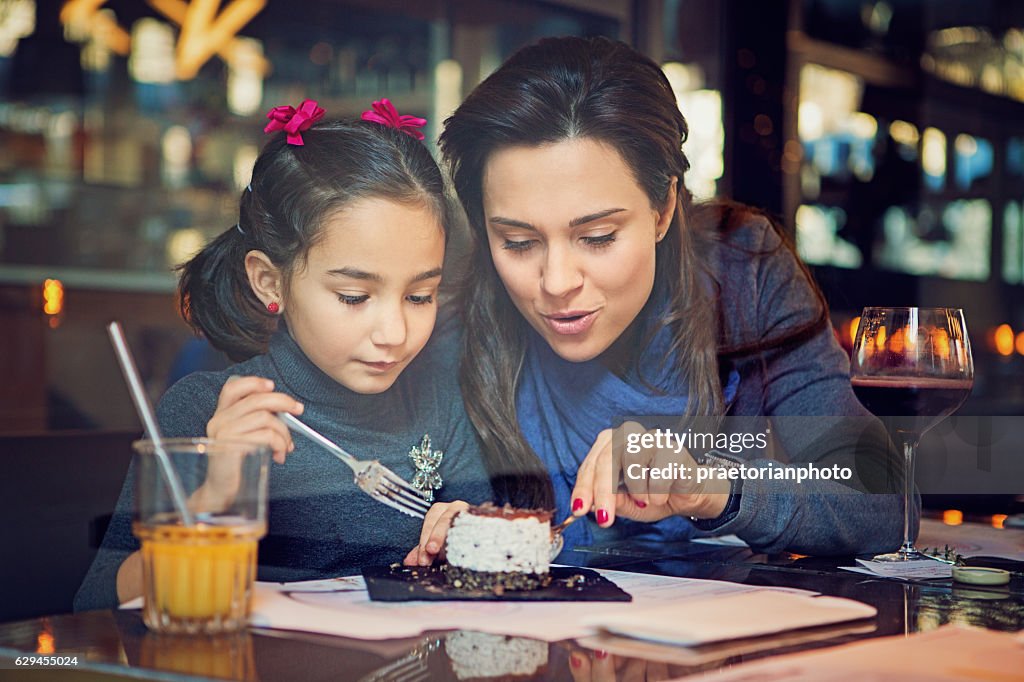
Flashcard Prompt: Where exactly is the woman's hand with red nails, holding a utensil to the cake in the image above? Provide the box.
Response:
[571,422,730,527]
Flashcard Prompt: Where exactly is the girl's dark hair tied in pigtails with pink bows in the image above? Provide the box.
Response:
[178,121,451,360]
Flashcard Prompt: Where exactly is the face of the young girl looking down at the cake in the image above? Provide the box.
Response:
[282,199,444,393]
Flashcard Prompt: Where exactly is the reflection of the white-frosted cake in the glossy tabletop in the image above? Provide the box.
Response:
[444,631,548,680]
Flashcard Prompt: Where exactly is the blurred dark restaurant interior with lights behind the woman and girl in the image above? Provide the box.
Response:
[0,0,1024,679]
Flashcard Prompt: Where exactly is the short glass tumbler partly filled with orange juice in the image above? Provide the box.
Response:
[132,438,270,634]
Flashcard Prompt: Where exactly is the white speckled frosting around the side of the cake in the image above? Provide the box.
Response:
[447,512,551,573]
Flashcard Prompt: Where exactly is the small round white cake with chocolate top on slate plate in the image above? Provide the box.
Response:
[444,503,551,593]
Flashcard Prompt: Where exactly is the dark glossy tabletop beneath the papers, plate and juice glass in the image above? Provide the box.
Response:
[0,531,1024,682]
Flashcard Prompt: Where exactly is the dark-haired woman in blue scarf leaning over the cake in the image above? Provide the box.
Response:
[407,38,901,563]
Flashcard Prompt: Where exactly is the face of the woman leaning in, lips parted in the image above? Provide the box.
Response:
[483,138,676,363]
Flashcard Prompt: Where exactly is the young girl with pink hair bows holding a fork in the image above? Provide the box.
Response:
[76,99,490,609]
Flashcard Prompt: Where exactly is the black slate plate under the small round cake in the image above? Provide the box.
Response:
[362,564,633,601]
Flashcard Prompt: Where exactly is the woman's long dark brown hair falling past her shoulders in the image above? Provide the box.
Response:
[439,38,826,507]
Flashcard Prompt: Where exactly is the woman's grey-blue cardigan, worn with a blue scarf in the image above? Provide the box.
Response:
[542,219,903,555]
